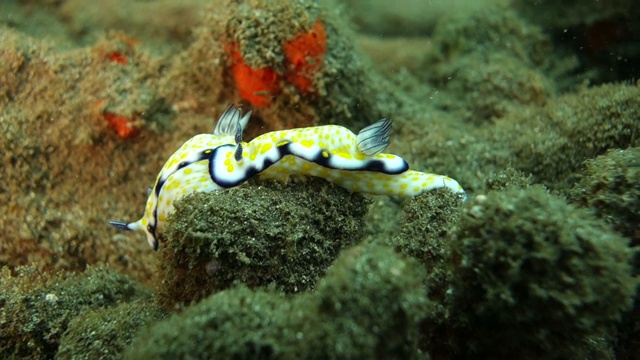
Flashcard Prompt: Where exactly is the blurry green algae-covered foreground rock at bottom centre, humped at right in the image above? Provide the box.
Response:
[125,246,427,359]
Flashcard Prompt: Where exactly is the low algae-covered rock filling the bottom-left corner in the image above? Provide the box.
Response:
[0,267,150,359]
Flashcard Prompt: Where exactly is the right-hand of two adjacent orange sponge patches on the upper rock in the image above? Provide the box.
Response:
[283,20,327,92]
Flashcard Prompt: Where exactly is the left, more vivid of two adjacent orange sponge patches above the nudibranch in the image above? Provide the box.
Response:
[226,44,280,108]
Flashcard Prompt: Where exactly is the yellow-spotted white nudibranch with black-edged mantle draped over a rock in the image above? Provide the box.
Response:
[109,106,466,250]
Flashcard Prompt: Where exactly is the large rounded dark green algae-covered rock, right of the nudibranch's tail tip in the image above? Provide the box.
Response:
[430,187,637,359]
